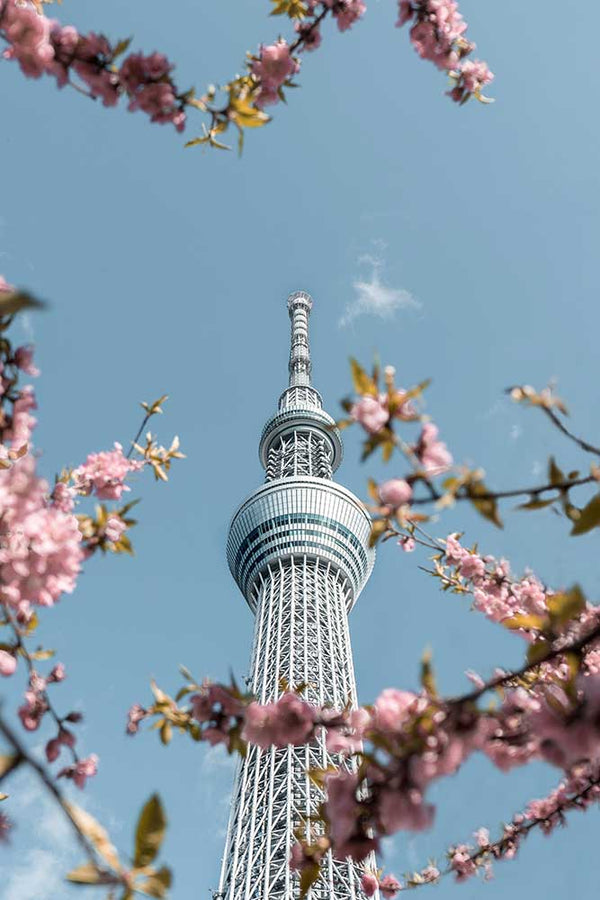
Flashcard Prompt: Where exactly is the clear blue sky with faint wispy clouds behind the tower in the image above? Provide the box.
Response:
[0,0,600,900]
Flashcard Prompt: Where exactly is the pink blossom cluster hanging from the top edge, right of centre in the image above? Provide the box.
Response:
[396,0,494,103]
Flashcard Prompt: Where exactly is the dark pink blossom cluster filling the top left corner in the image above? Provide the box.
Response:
[0,0,186,131]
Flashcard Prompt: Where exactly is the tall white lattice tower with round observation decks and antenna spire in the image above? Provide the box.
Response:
[216,291,375,900]
